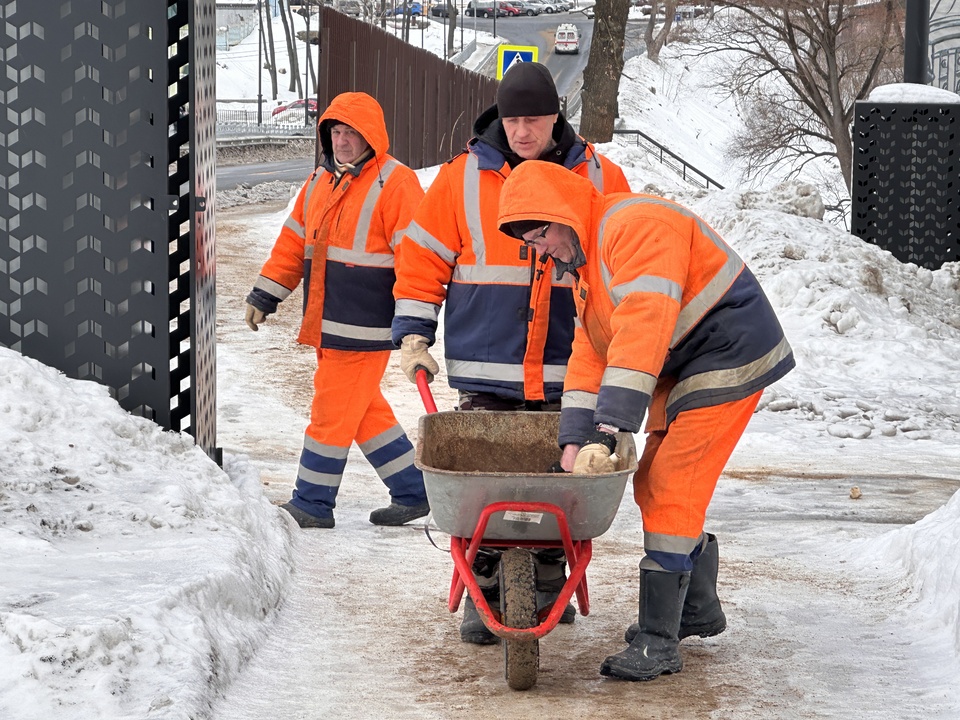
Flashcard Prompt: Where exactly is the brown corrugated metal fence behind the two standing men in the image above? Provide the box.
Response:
[317,8,497,168]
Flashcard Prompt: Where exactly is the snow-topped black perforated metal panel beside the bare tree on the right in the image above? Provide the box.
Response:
[852,101,960,268]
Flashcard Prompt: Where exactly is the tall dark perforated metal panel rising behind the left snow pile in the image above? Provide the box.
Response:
[0,0,216,454]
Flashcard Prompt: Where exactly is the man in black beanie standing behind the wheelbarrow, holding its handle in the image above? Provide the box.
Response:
[393,63,630,645]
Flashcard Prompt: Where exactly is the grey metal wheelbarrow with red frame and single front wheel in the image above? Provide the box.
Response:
[414,376,637,690]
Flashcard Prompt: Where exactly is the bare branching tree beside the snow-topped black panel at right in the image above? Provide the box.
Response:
[706,0,902,191]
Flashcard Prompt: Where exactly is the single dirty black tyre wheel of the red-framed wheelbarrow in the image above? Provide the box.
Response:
[500,548,540,690]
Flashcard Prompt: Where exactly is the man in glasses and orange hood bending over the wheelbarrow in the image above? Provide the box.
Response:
[499,162,795,680]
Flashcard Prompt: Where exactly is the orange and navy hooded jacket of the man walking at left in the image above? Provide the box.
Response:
[248,93,423,351]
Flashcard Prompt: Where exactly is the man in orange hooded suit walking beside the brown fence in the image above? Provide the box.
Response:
[246,93,430,528]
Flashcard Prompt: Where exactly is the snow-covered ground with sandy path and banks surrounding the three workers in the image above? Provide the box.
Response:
[0,12,960,720]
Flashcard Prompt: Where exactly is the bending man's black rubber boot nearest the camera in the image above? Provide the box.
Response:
[600,569,690,680]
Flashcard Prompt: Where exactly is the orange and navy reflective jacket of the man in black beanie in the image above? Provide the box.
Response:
[393,132,630,402]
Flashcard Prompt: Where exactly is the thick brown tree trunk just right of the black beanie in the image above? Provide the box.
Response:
[580,0,630,142]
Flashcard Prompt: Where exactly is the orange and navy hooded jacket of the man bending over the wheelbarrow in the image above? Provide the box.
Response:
[500,162,795,445]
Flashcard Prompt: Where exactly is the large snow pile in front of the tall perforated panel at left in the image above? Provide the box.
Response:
[0,348,292,718]
